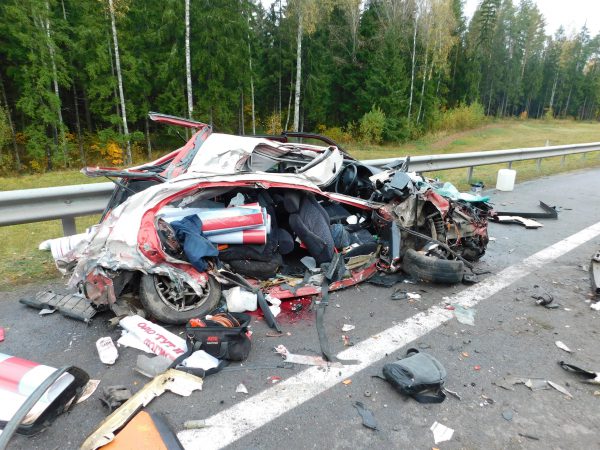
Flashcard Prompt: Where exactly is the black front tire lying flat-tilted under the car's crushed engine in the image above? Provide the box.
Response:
[402,249,465,284]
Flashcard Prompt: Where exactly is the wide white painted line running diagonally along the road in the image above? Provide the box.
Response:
[177,222,600,450]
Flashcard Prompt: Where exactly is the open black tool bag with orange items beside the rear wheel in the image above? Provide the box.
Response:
[185,313,252,361]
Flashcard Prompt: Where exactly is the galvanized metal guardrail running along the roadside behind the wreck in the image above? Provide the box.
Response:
[0,142,600,235]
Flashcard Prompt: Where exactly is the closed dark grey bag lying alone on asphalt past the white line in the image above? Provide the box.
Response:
[383,348,446,403]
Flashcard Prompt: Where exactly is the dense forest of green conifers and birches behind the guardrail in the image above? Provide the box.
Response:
[0,0,600,172]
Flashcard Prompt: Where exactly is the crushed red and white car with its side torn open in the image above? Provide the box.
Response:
[35,113,491,323]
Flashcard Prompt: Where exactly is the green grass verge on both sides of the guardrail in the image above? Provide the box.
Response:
[0,120,600,291]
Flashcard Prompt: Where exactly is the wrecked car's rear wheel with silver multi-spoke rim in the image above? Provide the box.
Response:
[140,275,221,325]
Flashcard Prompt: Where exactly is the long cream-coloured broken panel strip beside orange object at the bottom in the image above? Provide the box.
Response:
[81,369,202,450]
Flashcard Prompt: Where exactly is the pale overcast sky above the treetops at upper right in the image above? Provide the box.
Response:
[465,0,600,36]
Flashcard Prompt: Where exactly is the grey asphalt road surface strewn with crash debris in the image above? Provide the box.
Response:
[0,169,600,449]
